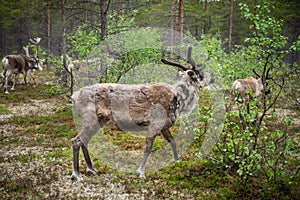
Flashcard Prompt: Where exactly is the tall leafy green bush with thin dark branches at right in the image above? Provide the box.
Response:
[200,3,299,192]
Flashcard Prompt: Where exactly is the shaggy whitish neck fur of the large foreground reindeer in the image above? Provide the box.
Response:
[174,81,199,114]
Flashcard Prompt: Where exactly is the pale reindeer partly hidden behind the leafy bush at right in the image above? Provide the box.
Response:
[226,68,271,113]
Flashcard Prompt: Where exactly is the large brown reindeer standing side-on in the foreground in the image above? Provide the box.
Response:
[71,47,211,180]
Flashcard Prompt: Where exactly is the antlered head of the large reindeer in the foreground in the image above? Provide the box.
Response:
[161,47,209,88]
